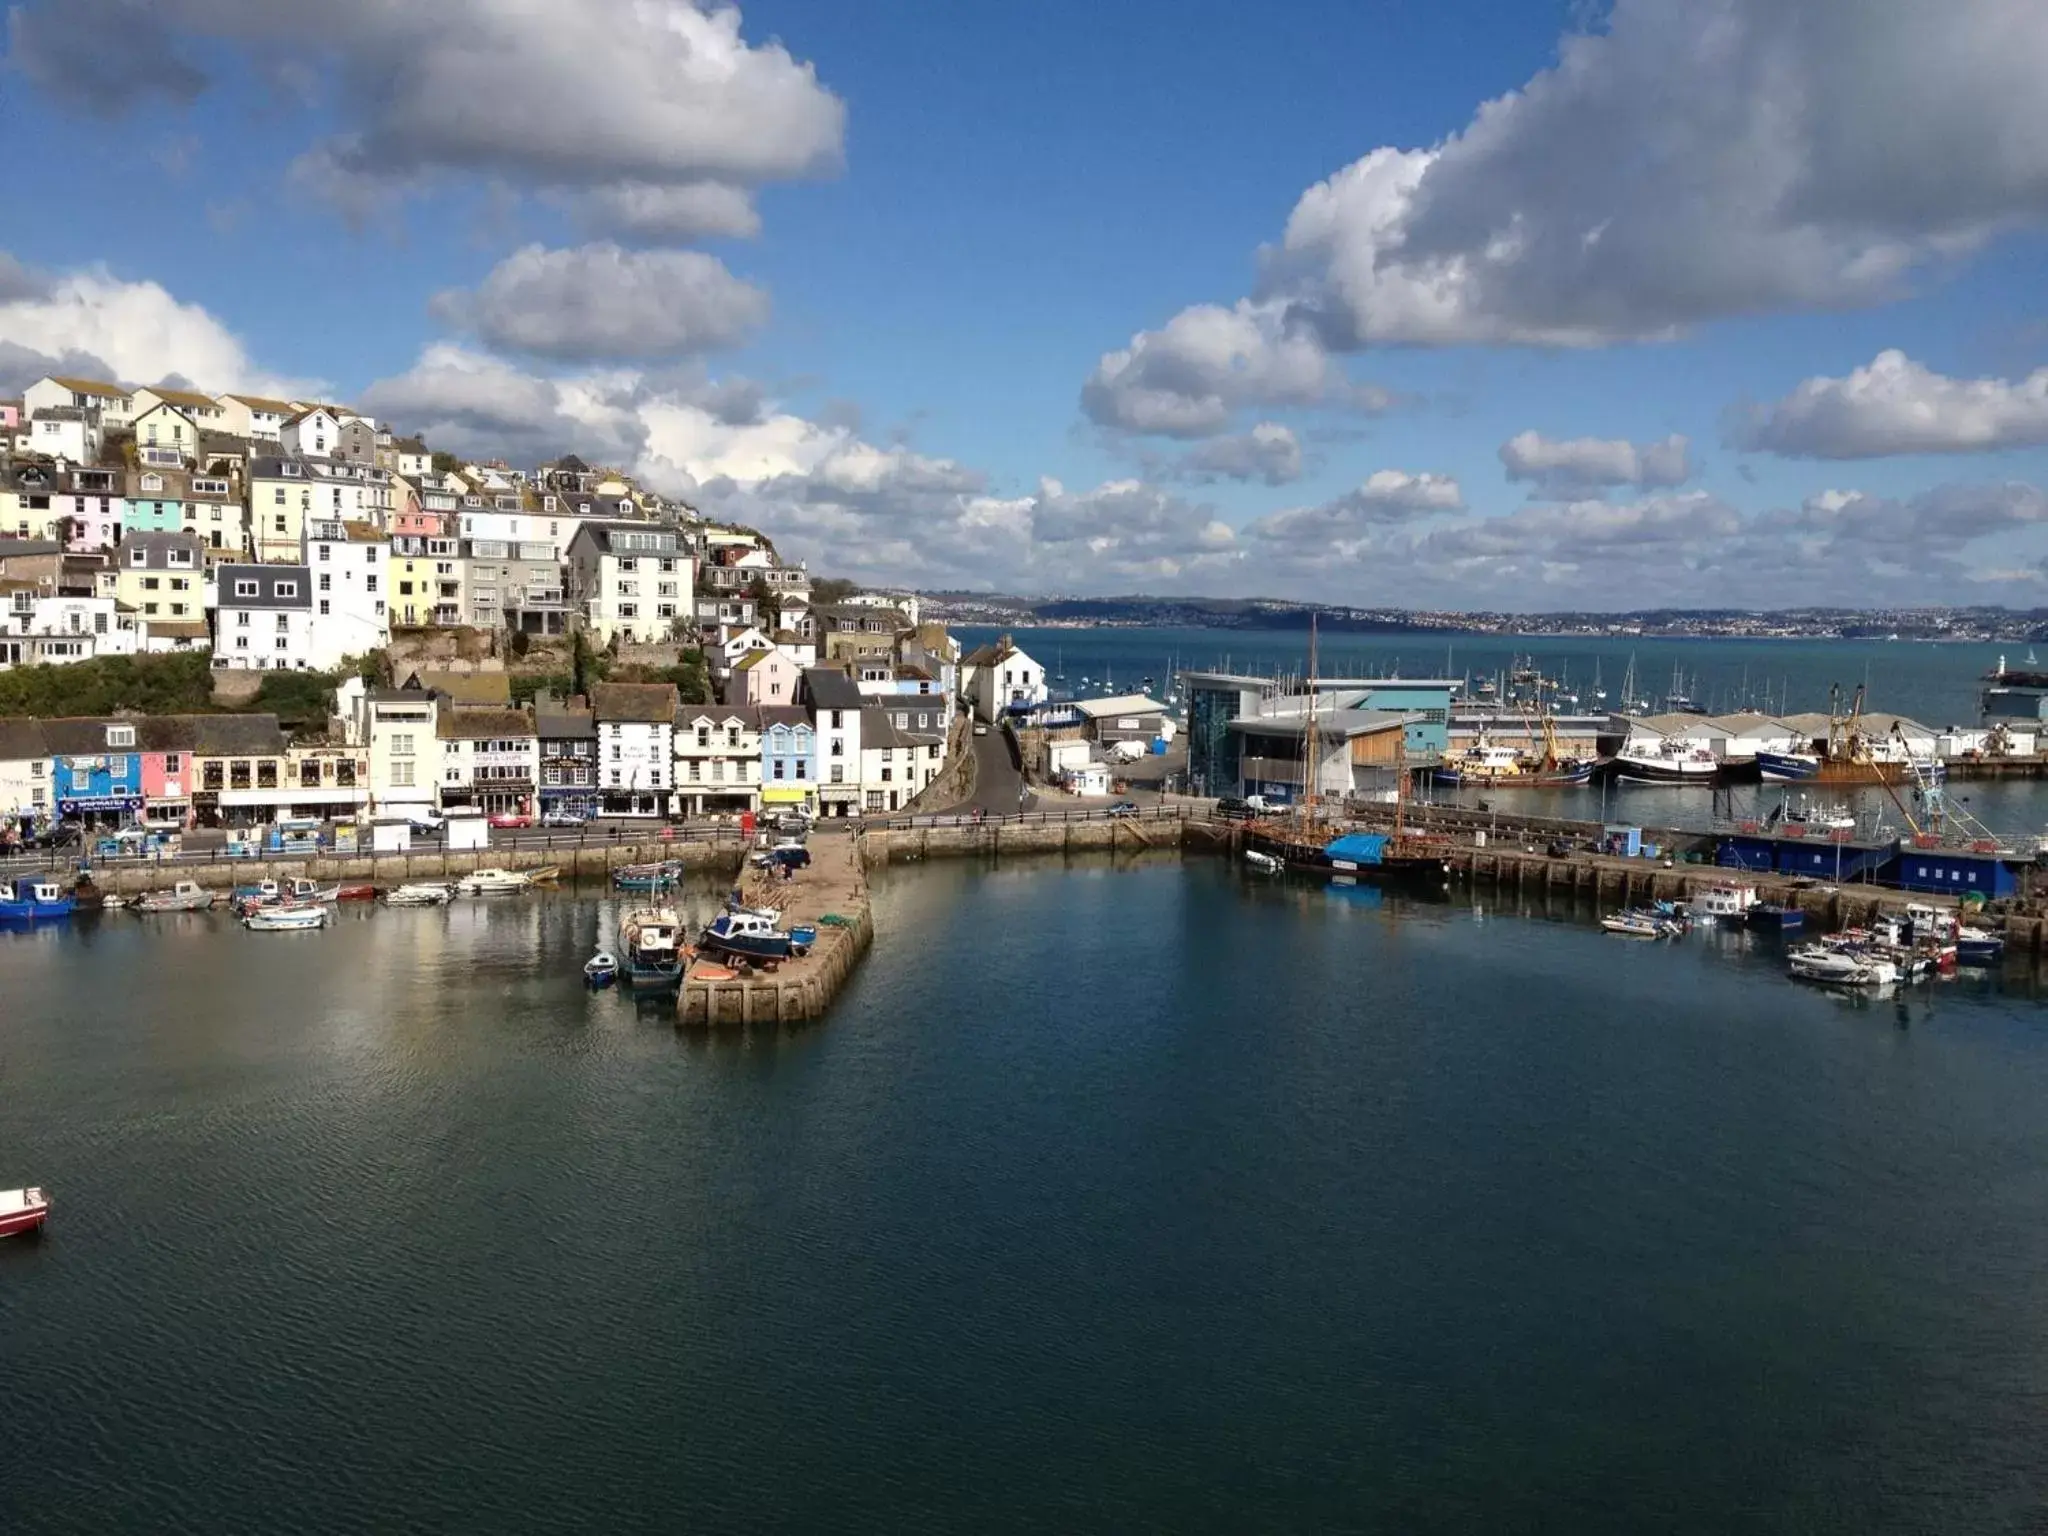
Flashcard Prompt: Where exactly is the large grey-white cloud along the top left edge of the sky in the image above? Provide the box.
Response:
[8,0,846,217]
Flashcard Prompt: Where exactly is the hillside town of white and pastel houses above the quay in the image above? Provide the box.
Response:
[0,377,1073,838]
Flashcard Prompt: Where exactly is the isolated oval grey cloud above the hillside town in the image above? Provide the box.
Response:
[432,244,768,360]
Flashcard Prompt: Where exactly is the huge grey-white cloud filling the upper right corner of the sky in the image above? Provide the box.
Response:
[1098,0,2048,397]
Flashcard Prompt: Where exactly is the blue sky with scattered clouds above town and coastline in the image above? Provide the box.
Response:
[0,0,2048,610]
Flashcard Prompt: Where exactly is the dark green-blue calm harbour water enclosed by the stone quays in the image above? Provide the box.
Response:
[0,858,2048,1536]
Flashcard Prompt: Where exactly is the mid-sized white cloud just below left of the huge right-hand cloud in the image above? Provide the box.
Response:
[1081,303,1393,438]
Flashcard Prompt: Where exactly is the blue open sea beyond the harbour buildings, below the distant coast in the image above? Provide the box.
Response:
[954,627,2048,848]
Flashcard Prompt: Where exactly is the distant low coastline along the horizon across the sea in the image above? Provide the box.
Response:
[920,592,2048,645]
